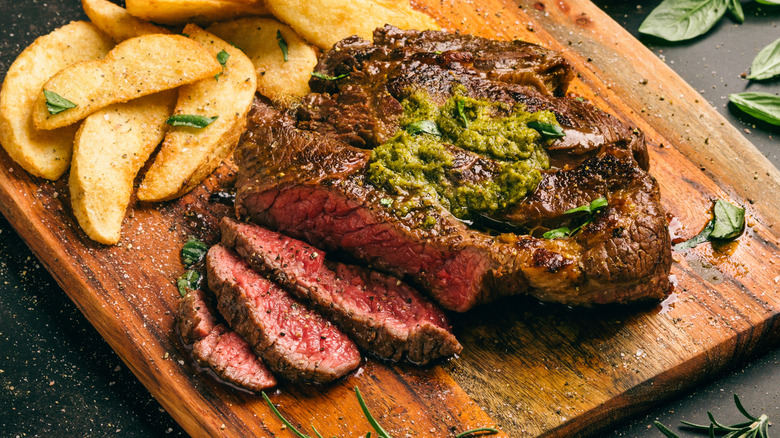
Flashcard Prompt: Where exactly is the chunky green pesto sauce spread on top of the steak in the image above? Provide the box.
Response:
[368,92,558,219]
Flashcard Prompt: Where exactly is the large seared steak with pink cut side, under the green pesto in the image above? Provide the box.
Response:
[235,27,671,311]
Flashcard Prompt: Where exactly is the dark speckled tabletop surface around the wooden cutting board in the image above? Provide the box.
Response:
[0,0,780,438]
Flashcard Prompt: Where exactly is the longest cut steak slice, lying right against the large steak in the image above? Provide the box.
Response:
[221,218,462,364]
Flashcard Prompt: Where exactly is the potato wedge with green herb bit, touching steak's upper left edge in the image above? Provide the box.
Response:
[208,17,317,102]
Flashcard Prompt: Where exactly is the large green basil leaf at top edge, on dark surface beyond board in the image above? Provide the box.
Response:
[639,0,732,41]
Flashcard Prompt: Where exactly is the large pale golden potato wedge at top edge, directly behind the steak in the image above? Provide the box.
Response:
[265,0,439,50]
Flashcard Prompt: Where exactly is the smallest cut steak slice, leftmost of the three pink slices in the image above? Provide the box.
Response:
[177,290,276,391]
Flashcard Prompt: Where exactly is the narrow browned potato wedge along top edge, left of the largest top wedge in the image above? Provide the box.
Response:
[125,0,268,24]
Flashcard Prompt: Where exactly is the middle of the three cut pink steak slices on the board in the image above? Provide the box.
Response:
[206,245,360,383]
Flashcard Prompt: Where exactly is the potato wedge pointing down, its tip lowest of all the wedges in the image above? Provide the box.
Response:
[68,90,177,245]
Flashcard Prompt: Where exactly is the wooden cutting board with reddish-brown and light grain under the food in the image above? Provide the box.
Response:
[0,0,780,437]
